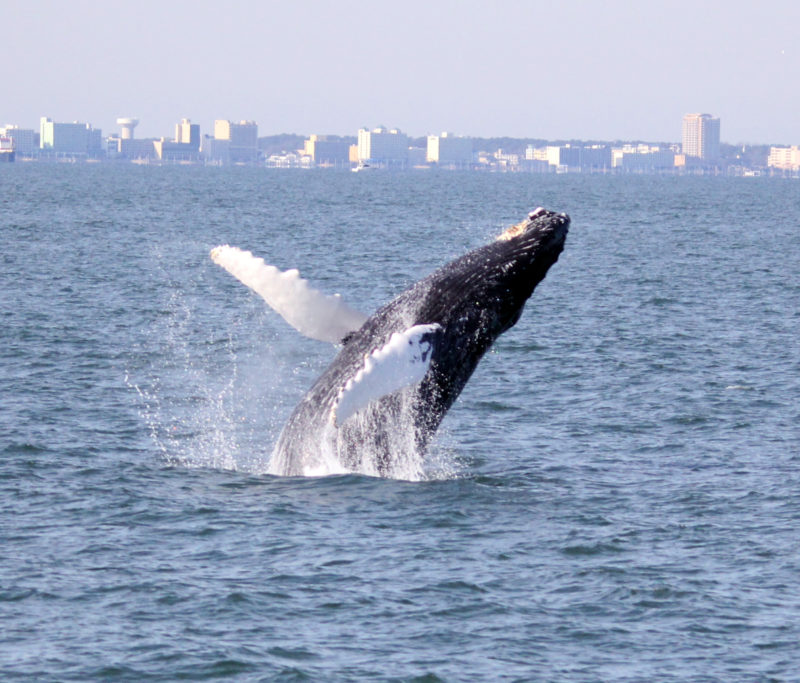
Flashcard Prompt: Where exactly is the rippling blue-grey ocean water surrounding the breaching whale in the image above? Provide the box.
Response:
[0,163,800,681]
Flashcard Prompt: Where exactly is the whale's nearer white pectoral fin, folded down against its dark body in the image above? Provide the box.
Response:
[331,323,442,427]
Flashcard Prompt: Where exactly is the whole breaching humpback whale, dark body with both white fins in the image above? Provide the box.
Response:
[211,207,570,476]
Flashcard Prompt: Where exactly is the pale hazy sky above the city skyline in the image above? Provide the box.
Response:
[0,0,800,144]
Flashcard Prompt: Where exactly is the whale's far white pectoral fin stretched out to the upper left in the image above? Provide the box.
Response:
[211,245,367,344]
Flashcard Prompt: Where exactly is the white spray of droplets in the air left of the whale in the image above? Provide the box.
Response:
[125,289,284,474]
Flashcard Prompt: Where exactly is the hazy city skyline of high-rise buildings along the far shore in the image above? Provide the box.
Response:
[6,113,800,175]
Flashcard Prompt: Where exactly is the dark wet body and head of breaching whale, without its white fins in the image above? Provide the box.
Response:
[273,209,569,474]
